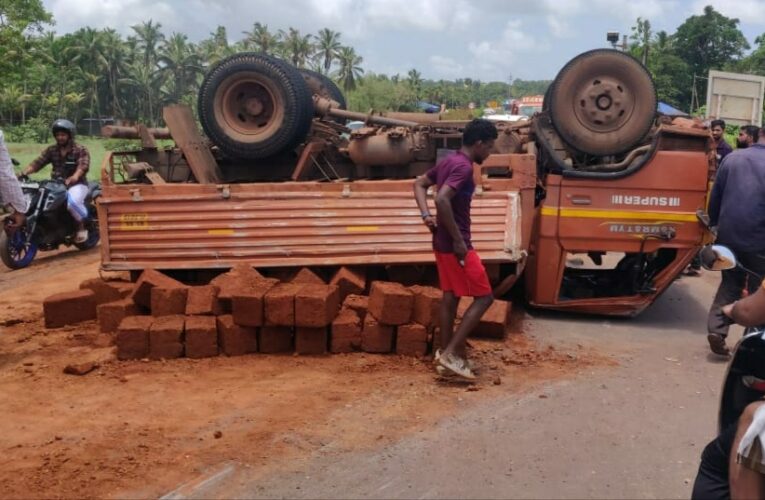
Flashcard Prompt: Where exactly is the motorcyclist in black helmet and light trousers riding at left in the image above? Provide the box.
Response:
[23,118,90,243]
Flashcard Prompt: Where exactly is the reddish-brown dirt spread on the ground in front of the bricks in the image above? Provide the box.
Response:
[0,263,614,497]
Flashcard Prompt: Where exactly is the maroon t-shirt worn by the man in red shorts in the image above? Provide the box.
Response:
[426,151,475,253]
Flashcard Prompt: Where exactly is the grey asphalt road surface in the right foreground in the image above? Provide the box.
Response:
[163,272,741,498]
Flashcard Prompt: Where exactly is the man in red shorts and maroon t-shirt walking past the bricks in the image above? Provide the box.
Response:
[414,119,497,379]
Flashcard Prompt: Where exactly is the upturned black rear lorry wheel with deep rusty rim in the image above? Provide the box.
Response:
[198,53,313,158]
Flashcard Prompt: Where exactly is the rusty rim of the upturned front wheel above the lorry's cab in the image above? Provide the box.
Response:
[574,77,635,132]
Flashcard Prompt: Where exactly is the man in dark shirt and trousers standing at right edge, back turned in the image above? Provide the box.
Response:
[707,125,765,356]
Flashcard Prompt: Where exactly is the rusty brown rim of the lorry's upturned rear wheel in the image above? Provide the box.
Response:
[210,72,285,143]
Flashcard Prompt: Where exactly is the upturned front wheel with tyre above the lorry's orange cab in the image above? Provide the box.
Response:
[549,49,657,156]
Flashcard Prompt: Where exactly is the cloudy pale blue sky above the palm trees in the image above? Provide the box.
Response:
[43,0,765,81]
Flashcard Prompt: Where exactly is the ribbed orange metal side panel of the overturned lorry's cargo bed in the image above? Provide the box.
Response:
[99,183,521,270]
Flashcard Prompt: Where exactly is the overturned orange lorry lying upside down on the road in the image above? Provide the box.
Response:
[98,50,715,315]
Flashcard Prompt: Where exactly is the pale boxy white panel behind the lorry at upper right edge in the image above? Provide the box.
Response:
[707,71,765,127]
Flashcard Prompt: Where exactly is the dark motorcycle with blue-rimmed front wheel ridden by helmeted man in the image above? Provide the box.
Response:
[0,177,101,269]
